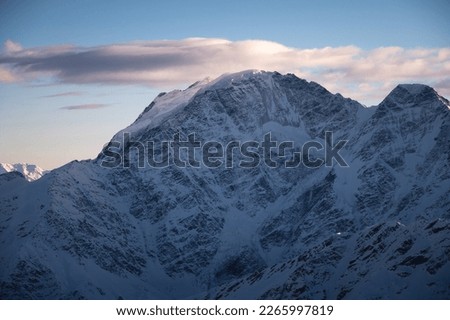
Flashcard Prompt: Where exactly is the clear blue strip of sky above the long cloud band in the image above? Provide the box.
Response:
[0,0,450,49]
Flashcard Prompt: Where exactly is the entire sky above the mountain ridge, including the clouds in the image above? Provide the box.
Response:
[0,0,450,169]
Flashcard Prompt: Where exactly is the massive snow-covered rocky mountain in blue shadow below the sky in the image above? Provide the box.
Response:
[0,71,450,299]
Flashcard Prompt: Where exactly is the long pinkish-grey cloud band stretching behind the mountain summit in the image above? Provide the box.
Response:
[0,38,450,102]
